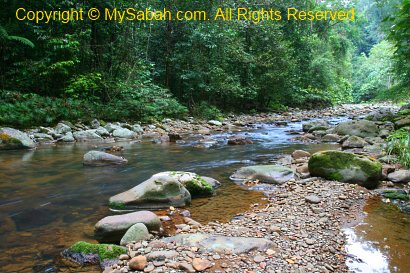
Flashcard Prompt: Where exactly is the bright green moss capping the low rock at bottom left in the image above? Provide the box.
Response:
[69,241,127,261]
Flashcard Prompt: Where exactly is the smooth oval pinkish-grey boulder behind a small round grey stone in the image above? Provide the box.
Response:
[94,211,161,243]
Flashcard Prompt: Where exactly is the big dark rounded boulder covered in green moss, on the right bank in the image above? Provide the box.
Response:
[309,151,382,189]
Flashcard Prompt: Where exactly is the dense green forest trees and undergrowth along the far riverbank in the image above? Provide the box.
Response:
[0,0,410,127]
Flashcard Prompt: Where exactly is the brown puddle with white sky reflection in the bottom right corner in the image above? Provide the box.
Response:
[345,198,410,273]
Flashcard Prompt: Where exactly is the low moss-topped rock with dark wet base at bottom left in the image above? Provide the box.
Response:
[62,241,127,265]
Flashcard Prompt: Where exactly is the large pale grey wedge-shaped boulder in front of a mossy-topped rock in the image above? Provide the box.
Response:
[110,172,193,209]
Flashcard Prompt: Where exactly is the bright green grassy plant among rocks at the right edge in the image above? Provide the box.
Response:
[387,128,410,168]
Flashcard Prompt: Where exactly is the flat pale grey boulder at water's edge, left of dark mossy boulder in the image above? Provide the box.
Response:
[230,165,295,184]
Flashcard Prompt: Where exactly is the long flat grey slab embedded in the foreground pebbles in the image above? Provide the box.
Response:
[162,233,274,254]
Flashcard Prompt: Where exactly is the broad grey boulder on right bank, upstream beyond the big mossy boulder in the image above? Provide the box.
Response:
[333,120,379,137]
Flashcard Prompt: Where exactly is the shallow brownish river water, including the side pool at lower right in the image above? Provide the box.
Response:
[0,119,410,273]
